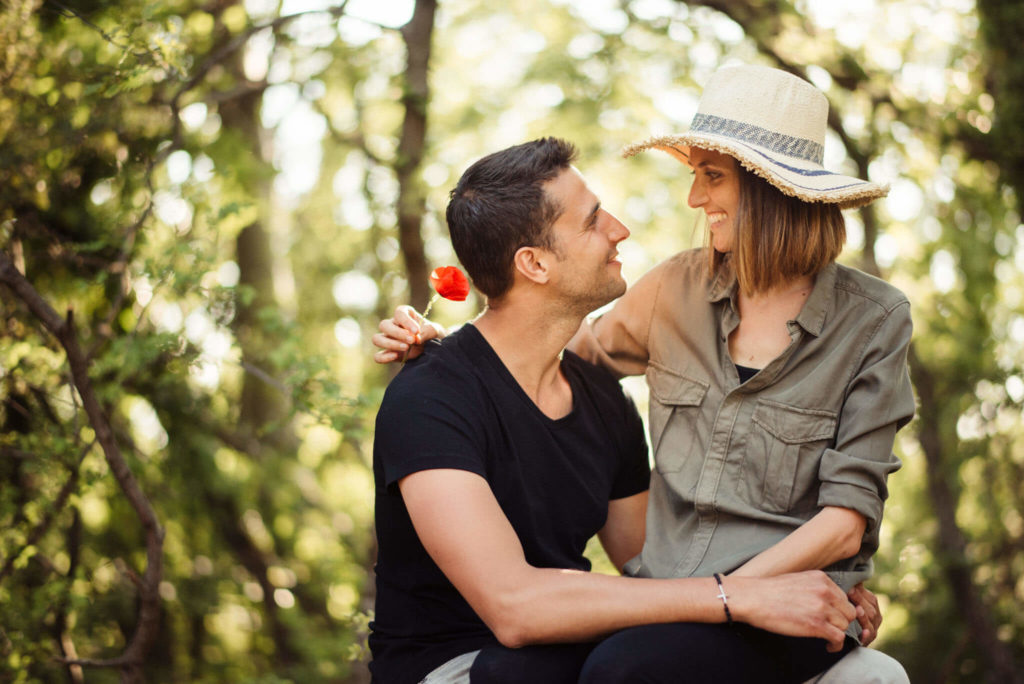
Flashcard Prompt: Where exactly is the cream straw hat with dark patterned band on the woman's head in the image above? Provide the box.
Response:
[623,66,889,209]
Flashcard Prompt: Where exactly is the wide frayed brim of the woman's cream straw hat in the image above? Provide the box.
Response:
[623,133,889,209]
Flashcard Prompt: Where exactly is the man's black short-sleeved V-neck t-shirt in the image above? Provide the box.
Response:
[370,325,650,684]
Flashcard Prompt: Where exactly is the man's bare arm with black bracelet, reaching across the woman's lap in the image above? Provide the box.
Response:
[398,469,855,648]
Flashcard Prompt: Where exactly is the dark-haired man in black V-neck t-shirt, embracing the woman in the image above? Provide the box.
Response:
[370,138,888,683]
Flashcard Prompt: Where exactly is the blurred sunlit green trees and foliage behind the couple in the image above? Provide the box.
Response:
[0,0,1024,682]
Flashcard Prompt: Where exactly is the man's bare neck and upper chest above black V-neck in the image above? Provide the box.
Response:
[473,300,583,419]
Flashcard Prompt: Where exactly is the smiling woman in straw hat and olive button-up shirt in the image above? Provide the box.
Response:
[377,67,913,682]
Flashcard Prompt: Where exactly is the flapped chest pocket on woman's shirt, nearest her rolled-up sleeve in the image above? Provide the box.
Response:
[744,398,837,513]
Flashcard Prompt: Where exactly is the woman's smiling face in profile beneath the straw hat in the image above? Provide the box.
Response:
[688,147,739,252]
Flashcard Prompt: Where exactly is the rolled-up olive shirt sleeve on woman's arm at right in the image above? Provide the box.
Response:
[818,301,914,535]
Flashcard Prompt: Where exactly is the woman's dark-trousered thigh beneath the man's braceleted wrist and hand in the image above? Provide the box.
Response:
[580,623,856,684]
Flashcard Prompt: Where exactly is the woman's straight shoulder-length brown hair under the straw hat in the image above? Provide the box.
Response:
[708,163,846,295]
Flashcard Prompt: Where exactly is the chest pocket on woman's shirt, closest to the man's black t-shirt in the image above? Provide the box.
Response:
[646,361,709,473]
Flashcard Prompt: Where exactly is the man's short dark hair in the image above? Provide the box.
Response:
[445,137,577,298]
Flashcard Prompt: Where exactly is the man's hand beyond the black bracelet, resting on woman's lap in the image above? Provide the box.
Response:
[722,570,857,652]
